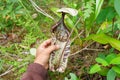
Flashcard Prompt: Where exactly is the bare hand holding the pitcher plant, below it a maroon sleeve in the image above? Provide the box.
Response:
[34,39,59,69]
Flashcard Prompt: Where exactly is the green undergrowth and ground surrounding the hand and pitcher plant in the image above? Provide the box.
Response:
[0,0,120,80]
